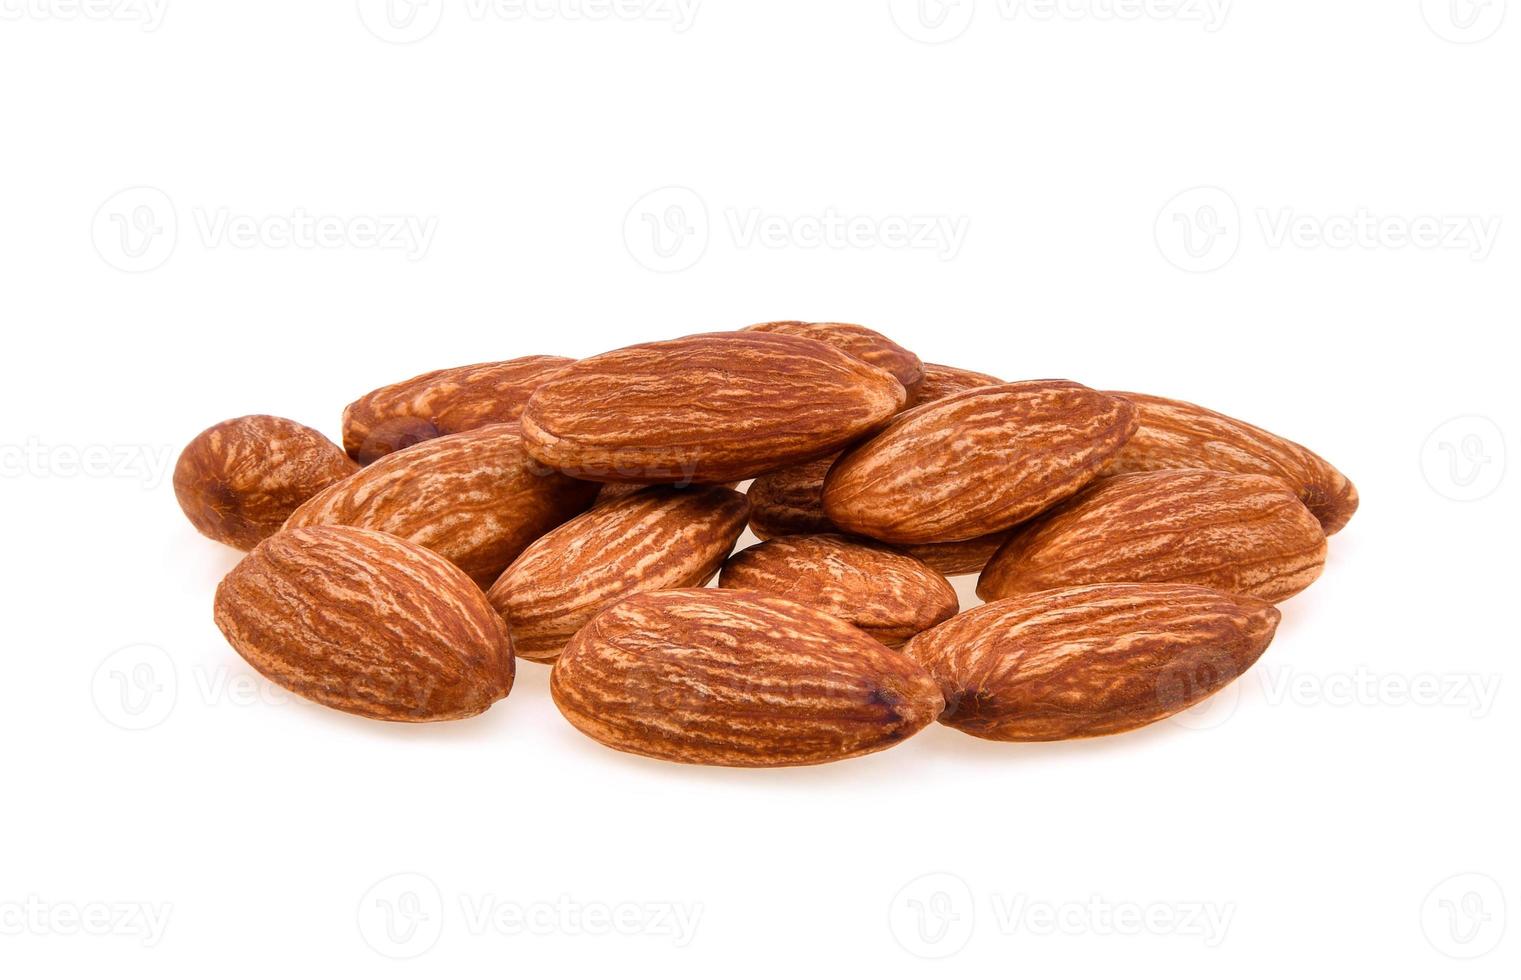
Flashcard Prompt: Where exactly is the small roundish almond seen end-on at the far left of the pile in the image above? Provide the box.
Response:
[175,415,359,551]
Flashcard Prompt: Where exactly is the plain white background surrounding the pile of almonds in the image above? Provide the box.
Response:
[0,0,1521,977]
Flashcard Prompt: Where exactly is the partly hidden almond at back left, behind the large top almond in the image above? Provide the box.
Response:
[344,355,573,464]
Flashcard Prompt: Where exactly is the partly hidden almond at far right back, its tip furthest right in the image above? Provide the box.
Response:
[1104,391,1358,536]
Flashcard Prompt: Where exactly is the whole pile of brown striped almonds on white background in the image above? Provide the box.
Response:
[175,321,1357,765]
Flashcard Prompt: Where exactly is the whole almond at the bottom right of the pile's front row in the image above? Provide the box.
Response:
[907,584,1279,741]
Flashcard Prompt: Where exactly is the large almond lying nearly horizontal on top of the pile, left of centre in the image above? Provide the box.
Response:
[522,332,907,484]
